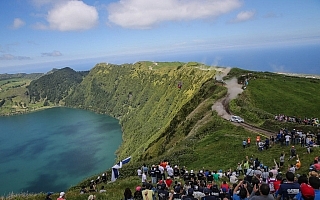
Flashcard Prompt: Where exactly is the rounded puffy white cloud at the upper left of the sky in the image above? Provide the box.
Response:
[47,1,98,31]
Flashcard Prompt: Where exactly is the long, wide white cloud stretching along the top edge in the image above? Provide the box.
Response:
[108,0,241,29]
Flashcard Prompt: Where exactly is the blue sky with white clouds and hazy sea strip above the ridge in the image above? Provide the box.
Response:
[0,0,320,74]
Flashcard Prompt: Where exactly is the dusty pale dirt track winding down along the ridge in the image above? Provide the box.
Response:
[212,68,275,136]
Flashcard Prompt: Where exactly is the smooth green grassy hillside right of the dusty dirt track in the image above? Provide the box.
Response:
[230,70,320,132]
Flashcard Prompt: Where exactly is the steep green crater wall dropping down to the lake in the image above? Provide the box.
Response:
[65,62,215,160]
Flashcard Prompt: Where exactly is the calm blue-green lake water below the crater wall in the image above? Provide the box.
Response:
[0,108,122,195]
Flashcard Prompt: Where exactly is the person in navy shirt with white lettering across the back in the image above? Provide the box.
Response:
[277,172,300,200]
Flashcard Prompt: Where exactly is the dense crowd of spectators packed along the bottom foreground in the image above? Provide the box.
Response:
[117,155,320,200]
